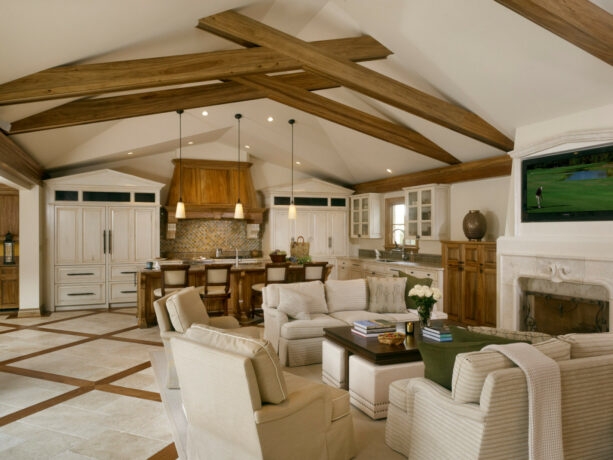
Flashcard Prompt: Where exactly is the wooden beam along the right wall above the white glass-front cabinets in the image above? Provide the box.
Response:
[353,155,512,193]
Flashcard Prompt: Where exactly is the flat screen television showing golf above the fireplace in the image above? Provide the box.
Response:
[521,144,613,222]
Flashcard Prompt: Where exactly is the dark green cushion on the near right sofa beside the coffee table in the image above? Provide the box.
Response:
[419,342,489,390]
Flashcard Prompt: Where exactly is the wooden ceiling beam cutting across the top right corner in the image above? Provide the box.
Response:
[496,0,613,65]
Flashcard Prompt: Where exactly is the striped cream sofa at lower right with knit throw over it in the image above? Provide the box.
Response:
[386,333,613,460]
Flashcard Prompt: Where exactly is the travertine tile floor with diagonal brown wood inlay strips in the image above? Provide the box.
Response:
[0,308,403,460]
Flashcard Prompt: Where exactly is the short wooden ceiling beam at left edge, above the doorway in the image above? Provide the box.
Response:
[0,132,44,189]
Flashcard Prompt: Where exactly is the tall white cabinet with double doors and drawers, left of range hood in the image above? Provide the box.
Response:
[45,170,163,308]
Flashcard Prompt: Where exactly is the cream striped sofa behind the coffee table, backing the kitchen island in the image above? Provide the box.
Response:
[262,279,447,367]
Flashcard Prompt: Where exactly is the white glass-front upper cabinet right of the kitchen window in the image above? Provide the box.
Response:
[403,184,450,240]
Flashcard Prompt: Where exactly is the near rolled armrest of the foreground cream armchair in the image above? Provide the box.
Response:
[254,384,332,424]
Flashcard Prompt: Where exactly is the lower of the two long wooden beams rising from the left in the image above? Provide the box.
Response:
[9,72,338,134]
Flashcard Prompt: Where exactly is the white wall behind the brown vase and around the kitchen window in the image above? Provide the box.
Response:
[351,176,510,255]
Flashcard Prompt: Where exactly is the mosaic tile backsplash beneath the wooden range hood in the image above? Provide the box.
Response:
[160,219,262,257]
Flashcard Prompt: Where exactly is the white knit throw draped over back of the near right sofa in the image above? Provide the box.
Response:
[483,343,564,460]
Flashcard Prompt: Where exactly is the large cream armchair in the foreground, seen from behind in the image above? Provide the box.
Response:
[171,331,355,460]
